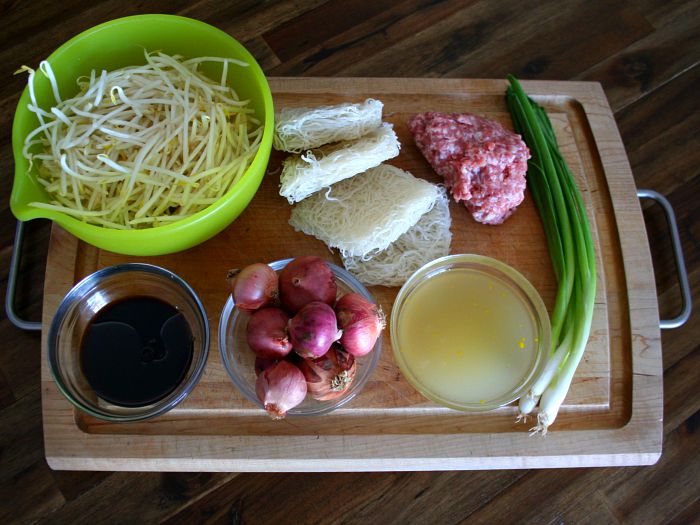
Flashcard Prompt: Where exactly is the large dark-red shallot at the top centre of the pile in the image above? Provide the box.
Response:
[279,255,338,315]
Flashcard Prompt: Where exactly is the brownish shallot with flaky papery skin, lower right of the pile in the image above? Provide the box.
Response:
[297,345,357,401]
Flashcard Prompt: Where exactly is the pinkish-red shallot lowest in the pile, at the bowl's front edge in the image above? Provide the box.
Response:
[255,361,307,419]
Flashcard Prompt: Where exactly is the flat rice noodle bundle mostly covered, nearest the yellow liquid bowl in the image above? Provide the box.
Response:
[342,188,452,286]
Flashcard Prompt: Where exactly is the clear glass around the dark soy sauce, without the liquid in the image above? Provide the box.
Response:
[48,263,209,421]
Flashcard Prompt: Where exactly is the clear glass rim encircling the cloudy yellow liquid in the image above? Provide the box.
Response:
[390,254,551,412]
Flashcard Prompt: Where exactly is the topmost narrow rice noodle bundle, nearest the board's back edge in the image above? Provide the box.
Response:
[273,98,384,153]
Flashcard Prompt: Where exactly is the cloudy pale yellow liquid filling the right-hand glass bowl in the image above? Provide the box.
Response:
[398,268,539,405]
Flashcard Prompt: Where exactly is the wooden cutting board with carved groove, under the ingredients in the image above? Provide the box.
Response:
[42,78,663,471]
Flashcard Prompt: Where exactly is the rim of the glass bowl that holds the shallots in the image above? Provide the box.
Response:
[218,257,382,417]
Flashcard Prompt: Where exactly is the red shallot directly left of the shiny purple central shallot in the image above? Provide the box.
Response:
[246,306,292,359]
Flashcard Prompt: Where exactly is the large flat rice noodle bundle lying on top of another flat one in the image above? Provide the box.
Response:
[289,164,440,257]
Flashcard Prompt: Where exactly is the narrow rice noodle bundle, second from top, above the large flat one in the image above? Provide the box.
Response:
[280,123,401,204]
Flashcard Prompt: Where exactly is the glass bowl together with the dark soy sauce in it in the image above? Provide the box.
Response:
[48,263,210,421]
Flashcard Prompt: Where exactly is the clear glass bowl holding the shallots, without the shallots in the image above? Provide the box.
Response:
[219,259,382,416]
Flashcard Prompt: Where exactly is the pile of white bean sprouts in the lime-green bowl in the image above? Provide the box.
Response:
[23,53,263,229]
